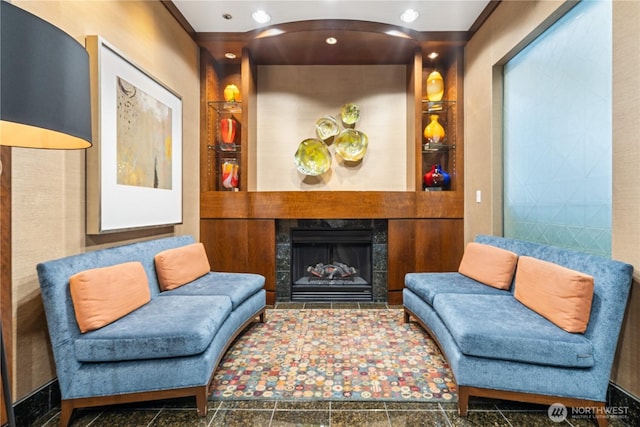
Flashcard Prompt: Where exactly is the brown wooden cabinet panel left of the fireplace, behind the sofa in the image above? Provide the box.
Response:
[200,219,276,304]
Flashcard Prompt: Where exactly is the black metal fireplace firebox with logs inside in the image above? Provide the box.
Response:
[291,228,373,301]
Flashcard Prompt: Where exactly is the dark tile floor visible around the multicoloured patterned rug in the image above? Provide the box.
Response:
[34,303,628,427]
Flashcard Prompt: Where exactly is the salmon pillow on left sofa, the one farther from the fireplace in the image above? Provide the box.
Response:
[69,262,151,333]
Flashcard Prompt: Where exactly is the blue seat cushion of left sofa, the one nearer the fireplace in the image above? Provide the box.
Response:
[161,271,264,310]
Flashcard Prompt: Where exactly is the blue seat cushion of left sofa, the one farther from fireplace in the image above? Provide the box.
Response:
[74,296,231,362]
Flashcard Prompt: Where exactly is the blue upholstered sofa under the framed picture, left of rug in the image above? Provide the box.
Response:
[37,236,266,426]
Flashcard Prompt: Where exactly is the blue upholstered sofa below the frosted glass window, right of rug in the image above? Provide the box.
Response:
[403,236,633,426]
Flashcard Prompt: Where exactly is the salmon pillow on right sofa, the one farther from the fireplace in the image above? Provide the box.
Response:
[514,256,593,333]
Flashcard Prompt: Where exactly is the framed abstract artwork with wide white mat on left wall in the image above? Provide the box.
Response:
[86,36,182,234]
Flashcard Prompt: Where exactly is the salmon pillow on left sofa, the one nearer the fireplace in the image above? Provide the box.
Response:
[155,243,211,291]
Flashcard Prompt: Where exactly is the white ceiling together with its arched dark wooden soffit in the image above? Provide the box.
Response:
[164,0,499,65]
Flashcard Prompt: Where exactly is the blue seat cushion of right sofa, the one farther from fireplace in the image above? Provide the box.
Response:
[433,294,594,368]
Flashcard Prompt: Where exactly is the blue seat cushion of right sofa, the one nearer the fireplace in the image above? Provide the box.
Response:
[404,272,511,305]
